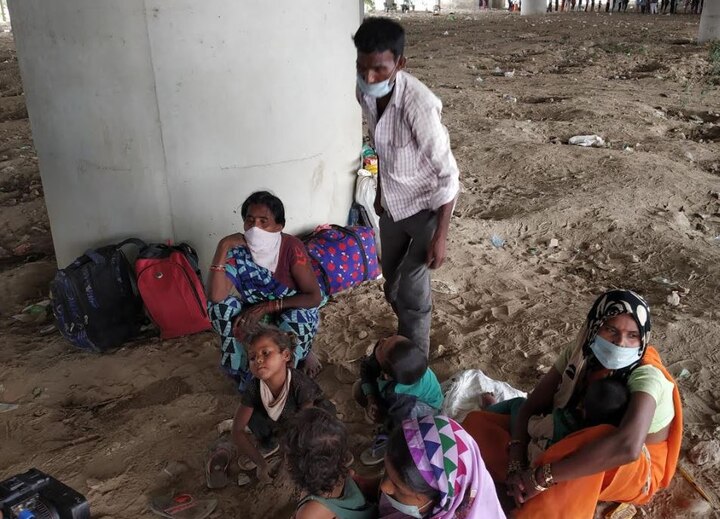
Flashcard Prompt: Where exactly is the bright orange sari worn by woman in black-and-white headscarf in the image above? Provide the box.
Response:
[462,346,682,519]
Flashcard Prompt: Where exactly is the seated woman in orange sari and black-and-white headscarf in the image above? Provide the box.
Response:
[463,290,682,519]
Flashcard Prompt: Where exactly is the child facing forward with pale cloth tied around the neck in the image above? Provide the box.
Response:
[232,326,335,482]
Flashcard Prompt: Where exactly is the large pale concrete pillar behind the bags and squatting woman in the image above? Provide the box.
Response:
[10,0,361,266]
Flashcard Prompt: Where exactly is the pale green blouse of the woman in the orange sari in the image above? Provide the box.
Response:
[555,345,675,434]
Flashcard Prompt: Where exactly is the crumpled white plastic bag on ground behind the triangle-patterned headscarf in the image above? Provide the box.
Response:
[442,369,527,422]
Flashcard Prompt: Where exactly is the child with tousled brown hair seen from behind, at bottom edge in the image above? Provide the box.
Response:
[282,407,377,519]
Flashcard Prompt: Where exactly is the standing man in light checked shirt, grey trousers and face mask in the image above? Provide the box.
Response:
[354,18,460,356]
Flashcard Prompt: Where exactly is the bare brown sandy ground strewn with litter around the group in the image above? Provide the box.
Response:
[0,12,720,518]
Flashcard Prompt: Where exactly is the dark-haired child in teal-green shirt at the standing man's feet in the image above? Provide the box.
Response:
[353,335,443,465]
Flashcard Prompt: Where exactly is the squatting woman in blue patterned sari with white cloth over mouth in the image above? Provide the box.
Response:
[208,191,321,391]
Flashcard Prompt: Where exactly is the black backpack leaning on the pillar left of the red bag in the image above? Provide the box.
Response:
[50,238,145,352]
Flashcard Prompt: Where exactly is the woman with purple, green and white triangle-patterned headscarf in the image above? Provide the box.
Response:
[357,416,505,519]
